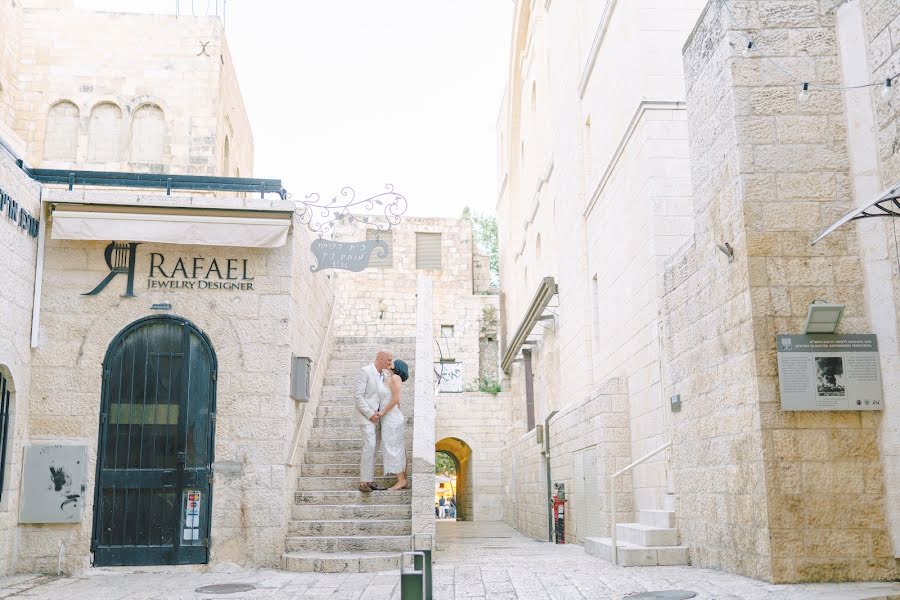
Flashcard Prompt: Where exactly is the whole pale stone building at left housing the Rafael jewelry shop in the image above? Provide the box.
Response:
[0,0,333,574]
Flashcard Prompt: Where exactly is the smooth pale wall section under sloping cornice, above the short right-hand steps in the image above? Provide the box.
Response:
[587,101,693,509]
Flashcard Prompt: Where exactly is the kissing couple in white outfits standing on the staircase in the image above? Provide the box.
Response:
[355,350,409,492]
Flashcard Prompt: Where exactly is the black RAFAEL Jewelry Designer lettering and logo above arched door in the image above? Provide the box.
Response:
[82,242,255,297]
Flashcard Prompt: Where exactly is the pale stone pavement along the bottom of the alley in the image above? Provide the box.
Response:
[0,522,900,600]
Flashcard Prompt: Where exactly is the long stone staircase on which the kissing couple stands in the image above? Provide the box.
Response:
[284,337,415,573]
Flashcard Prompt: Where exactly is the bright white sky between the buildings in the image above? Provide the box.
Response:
[76,0,514,217]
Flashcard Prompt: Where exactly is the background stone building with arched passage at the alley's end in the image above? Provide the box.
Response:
[334,217,508,521]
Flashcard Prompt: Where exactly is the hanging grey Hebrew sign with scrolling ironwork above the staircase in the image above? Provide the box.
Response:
[295,184,407,273]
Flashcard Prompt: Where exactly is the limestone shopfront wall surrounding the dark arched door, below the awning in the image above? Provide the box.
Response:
[15,192,330,572]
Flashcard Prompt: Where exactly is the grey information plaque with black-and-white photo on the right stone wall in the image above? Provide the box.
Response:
[775,334,883,410]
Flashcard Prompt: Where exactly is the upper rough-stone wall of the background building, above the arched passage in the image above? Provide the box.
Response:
[332,217,499,389]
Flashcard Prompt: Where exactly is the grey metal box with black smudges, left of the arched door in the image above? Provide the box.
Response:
[19,444,88,523]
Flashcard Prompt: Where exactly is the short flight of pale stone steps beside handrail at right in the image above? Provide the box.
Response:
[584,497,690,567]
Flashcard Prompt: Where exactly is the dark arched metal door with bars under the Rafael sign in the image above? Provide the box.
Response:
[91,315,216,565]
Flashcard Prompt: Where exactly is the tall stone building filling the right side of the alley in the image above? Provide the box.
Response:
[498,0,900,581]
